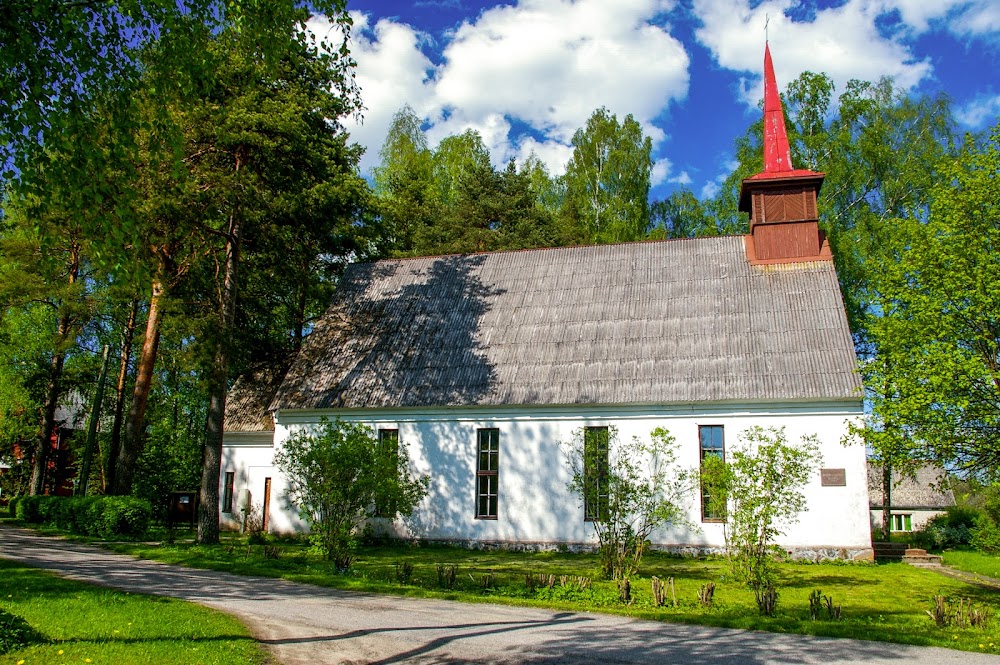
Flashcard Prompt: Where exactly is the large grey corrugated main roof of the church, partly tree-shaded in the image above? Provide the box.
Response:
[272,236,861,409]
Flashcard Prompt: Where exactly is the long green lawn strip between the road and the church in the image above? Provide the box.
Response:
[107,540,1000,653]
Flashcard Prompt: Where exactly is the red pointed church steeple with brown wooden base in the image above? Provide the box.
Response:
[739,43,830,263]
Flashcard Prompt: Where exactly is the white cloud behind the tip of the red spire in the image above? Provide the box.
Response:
[694,0,932,105]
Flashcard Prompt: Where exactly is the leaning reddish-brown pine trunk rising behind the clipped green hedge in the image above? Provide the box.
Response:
[111,272,165,495]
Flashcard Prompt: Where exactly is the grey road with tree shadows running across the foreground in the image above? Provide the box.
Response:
[0,527,1000,665]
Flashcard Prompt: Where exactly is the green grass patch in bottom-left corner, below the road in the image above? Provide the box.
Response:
[0,559,270,665]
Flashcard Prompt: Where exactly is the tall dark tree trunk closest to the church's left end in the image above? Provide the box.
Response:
[198,178,241,545]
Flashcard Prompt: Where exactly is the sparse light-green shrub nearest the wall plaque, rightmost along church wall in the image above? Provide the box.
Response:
[702,426,821,616]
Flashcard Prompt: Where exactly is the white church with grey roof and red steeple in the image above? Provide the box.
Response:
[220,44,872,558]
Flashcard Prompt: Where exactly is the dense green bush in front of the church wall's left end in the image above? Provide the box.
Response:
[274,418,428,569]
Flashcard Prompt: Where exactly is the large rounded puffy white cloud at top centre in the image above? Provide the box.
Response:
[436,0,689,143]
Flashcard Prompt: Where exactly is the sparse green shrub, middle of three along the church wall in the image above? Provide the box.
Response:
[563,427,691,581]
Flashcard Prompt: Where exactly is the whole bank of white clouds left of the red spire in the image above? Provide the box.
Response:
[324,0,690,173]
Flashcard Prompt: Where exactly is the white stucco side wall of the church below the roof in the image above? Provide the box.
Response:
[222,403,871,552]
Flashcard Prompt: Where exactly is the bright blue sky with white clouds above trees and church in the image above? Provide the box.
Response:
[322,0,1000,198]
